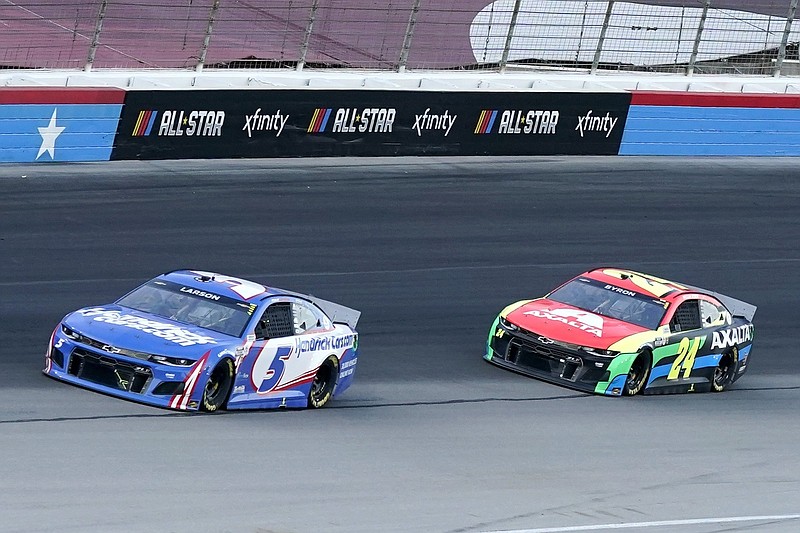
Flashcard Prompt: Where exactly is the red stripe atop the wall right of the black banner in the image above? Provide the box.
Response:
[631,91,800,109]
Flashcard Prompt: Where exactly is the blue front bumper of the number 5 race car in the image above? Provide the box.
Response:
[43,325,202,410]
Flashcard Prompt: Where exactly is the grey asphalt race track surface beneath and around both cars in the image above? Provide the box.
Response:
[0,157,800,533]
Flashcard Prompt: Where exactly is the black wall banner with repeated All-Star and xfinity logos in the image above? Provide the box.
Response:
[112,89,631,159]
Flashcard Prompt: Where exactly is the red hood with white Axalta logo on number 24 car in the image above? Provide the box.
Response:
[506,298,648,350]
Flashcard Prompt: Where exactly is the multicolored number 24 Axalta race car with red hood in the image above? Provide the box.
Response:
[484,268,756,396]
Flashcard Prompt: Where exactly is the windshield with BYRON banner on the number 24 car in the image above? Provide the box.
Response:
[549,278,666,330]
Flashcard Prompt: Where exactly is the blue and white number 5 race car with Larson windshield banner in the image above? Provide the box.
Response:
[44,270,361,411]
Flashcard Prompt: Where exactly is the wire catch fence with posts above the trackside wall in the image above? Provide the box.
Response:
[0,0,800,76]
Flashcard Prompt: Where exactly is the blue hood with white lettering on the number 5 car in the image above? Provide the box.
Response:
[63,305,233,359]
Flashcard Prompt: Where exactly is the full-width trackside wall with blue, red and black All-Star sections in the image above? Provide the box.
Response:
[0,83,800,163]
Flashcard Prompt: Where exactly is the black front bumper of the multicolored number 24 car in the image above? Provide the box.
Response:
[484,321,622,396]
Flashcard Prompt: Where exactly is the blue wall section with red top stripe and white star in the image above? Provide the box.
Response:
[0,88,125,162]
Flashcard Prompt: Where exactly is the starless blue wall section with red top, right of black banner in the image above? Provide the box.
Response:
[619,93,800,156]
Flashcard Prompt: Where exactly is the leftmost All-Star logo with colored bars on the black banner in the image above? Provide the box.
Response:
[131,109,225,137]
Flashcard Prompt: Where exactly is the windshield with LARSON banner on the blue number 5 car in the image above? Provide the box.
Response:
[117,280,256,337]
